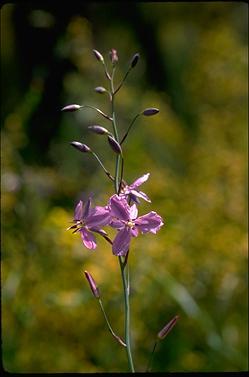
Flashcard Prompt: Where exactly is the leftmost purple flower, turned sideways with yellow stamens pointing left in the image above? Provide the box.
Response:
[67,198,110,249]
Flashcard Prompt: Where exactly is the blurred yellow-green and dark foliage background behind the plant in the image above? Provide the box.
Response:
[1,2,248,373]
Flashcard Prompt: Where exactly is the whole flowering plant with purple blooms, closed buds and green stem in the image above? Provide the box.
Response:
[61,49,167,373]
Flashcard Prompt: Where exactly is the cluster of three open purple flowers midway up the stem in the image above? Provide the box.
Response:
[68,173,163,256]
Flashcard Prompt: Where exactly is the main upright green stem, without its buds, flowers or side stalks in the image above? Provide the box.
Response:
[110,67,135,373]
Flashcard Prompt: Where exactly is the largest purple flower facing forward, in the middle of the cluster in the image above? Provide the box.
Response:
[109,195,163,256]
